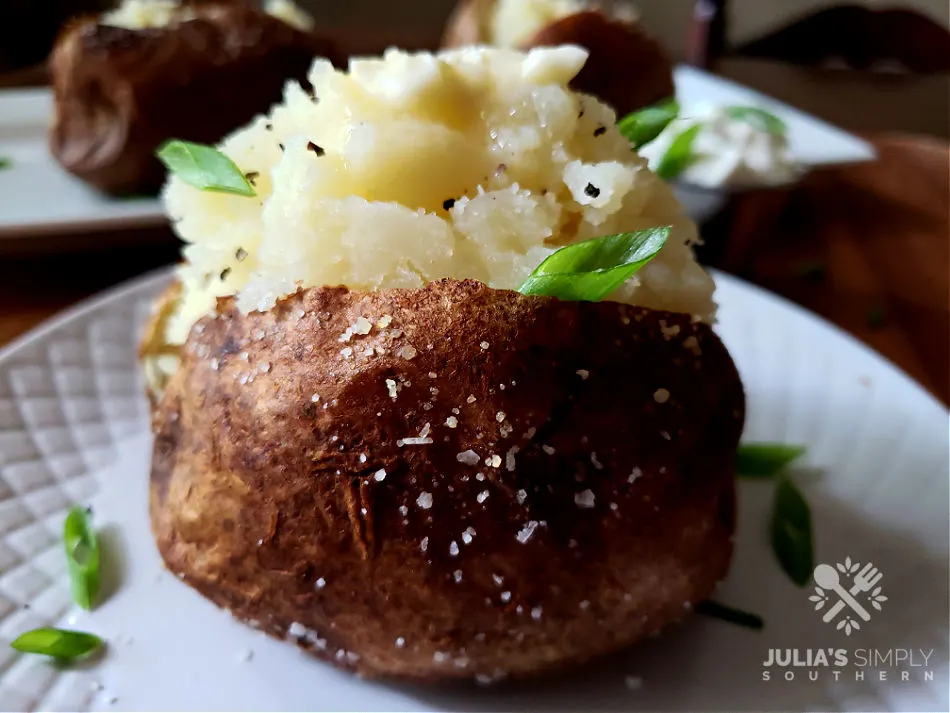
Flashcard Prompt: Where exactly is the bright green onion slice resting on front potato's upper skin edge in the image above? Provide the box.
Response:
[518,227,670,302]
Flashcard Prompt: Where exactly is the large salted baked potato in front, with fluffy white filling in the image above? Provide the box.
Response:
[142,47,744,681]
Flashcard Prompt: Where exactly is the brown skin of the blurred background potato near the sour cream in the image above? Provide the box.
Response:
[442,0,675,118]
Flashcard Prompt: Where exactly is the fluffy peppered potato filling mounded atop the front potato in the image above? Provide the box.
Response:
[164,46,715,344]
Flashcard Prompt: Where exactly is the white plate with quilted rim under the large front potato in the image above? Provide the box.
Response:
[0,273,950,713]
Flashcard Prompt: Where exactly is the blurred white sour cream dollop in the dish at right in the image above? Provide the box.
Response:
[639,104,802,188]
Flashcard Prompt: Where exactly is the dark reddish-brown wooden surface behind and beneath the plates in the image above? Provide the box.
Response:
[0,60,950,403]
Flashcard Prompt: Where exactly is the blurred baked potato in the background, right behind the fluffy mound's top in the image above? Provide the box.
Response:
[442,0,675,116]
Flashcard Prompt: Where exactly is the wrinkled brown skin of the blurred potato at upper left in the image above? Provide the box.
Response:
[49,3,344,195]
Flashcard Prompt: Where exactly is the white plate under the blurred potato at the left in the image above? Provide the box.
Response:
[0,88,166,239]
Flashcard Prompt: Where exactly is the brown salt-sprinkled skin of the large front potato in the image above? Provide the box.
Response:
[150,280,744,680]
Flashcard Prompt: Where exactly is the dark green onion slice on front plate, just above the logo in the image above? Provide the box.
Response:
[771,477,815,587]
